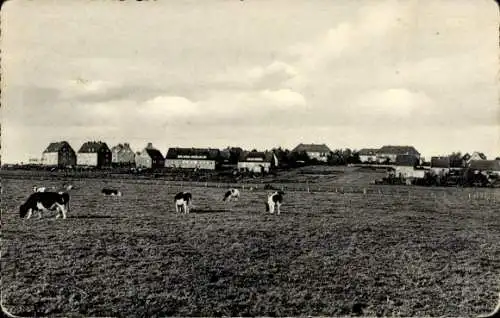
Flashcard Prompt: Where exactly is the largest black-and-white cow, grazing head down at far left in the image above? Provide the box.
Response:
[19,192,69,219]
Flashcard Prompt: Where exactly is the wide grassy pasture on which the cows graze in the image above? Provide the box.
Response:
[1,170,500,317]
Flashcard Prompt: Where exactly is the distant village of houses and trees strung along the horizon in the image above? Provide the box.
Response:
[2,141,500,187]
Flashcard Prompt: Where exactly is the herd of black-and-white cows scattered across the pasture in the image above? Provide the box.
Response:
[19,185,285,219]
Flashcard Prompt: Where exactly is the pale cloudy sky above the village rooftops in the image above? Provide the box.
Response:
[1,0,500,163]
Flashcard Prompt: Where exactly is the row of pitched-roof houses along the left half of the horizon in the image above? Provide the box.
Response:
[41,141,278,173]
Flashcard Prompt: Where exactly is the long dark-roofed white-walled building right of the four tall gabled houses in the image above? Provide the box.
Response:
[165,147,221,170]
